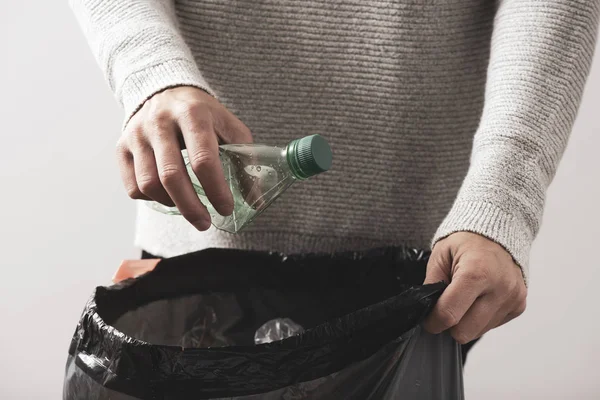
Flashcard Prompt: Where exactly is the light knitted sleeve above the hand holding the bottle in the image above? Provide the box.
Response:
[70,0,212,121]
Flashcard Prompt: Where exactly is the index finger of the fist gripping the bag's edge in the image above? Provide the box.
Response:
[424,270,488,334]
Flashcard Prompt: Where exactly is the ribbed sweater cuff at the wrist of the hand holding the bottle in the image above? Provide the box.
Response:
[118,59,216,126]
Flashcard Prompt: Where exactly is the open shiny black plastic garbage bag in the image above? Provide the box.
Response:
[63,248,463,400]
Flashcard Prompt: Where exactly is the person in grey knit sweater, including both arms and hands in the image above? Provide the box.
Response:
[72,0,600,360]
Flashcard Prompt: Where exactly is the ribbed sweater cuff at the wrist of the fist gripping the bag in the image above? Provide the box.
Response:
[432,200,533,285]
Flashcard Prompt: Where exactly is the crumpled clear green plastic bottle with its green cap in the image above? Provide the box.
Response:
[148,135,332,233]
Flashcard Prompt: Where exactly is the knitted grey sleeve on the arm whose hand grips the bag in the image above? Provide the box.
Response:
[434,0,600,282]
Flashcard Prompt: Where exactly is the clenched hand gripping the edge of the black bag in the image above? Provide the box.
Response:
[425,232,527,344]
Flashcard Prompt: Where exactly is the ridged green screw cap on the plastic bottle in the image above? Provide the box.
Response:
[287,135,332,179]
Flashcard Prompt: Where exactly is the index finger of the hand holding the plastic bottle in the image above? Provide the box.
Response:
[178,105,233,215]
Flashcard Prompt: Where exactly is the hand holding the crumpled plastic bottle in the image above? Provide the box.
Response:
[117,86,252,231]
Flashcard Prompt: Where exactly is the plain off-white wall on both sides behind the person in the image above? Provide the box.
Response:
[0,1,600,400]
